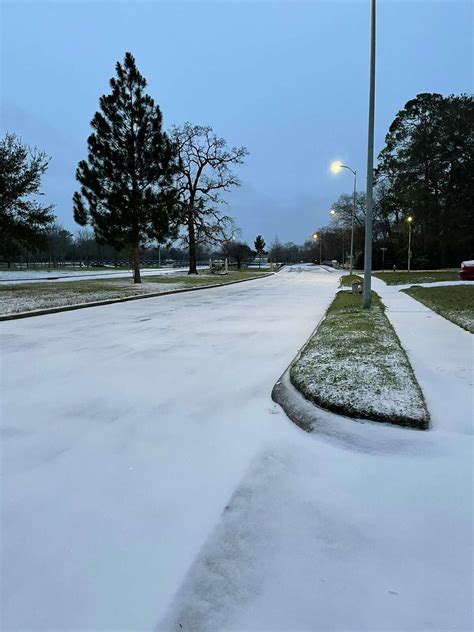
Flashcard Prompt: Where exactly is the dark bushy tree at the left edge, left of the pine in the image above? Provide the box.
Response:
[0,134,54,261]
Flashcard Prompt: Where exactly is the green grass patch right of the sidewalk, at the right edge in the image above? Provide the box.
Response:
[402,283,474,334]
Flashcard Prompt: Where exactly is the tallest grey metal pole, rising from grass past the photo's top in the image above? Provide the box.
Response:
[364,0,375,309]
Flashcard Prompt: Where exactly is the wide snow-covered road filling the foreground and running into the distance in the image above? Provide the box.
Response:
[0,268,472,632]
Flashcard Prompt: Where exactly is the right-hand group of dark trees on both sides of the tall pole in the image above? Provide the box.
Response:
[320,93,474,269]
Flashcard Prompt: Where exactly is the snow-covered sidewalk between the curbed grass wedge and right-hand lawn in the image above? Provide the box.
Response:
[372,277,474,434]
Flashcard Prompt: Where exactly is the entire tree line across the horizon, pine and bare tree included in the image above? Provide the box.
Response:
[0,81,474,274]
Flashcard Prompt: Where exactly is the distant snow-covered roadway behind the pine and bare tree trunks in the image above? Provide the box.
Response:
[0,266,204,284]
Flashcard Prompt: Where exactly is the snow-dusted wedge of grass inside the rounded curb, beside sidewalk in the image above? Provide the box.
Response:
[290,292,429,428]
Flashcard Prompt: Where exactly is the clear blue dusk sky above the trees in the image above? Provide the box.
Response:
[1,0,473,243]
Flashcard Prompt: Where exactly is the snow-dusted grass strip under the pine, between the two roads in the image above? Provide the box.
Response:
[0,270,268,315]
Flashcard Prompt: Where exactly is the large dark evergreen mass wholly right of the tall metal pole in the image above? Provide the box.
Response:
[376,93,474,266]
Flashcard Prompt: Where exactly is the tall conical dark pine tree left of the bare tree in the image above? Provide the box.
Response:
[73,53,178,283]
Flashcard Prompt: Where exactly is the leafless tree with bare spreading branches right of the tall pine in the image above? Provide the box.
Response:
[171,123,248,274]
